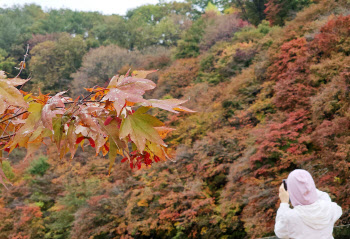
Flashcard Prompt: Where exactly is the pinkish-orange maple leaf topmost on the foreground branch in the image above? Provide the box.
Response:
[102,76,156,116]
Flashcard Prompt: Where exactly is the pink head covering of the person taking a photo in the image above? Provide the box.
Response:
[287,169,318,207]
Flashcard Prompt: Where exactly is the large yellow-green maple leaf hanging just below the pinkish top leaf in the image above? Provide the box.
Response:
[120,107,166,152]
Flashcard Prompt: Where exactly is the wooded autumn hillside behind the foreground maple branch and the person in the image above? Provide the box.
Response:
[0,0,350,239]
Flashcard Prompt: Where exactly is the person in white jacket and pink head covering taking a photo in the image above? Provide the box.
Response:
[275,169,342,239]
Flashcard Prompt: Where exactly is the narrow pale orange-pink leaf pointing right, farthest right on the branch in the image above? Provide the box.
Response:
[142,99,196,113]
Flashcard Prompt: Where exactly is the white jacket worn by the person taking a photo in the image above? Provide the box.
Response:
[275,190,342,239]
